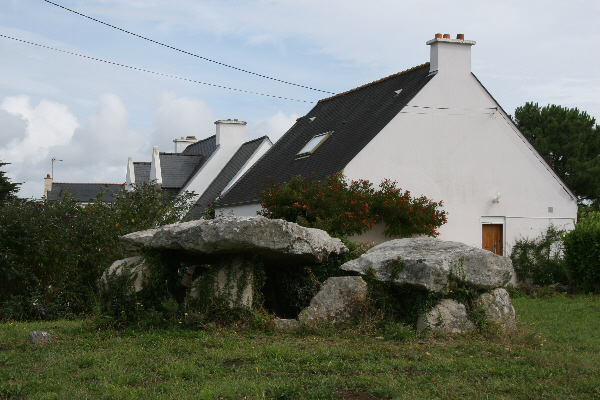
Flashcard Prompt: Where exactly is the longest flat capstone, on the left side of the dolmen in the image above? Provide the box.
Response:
[121,216,348,263]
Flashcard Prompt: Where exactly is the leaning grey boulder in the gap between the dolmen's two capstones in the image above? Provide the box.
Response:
[298,276,367,325]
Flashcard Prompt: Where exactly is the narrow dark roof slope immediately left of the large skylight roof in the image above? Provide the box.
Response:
[191,136,269,219]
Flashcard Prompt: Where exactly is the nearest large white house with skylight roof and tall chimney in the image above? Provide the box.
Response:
[220,34,577,255]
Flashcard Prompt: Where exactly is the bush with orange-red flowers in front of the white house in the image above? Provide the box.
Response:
[259,174,447,237]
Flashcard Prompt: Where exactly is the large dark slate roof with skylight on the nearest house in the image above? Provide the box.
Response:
[219,63,433,206]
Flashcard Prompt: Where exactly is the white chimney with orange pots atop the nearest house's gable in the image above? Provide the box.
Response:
[427,33,475,75]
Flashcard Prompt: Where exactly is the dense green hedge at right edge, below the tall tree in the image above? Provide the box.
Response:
[564,211,600,292]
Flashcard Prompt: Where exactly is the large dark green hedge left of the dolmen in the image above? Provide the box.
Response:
[0,185,197,319]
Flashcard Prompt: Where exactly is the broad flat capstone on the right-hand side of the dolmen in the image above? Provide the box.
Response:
[341,237,514,292]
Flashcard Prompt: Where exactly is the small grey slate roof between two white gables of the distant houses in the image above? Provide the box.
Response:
[158,153,206,189]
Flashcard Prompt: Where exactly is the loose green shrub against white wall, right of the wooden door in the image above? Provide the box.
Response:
[510,225,569,285]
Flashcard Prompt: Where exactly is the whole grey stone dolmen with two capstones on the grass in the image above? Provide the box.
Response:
[102,216,516,333]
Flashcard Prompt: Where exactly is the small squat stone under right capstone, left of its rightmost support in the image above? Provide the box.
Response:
[417,299,475,333]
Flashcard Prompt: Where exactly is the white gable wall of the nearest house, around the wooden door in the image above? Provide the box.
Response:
[344,42,577,254]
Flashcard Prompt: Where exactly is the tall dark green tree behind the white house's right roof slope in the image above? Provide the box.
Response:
[515,103,600,204]
